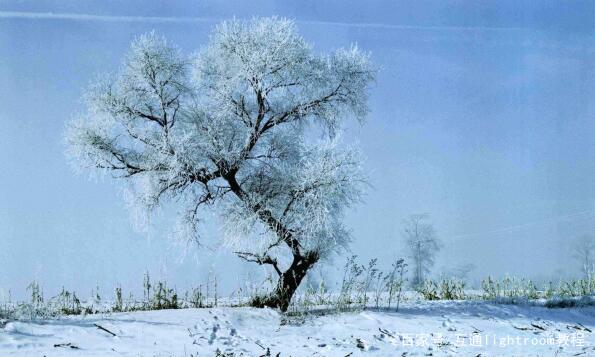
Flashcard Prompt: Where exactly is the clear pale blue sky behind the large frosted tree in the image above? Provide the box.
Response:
[0,0,595,298]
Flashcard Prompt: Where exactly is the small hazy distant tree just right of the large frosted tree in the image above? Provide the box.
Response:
[403,214,441,286]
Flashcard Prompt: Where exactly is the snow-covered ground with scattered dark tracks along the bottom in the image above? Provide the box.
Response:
[0,301,595,357]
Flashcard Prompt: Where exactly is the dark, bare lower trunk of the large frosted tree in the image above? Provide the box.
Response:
[263,252,318,312]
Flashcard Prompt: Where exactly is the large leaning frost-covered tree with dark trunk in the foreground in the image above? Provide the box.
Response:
[67,18,375,310]
